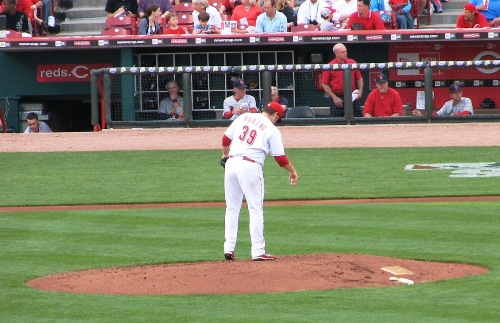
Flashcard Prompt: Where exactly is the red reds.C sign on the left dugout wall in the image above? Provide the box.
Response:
[36,63,111,83]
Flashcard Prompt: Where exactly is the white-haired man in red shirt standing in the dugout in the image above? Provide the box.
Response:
[321,43,364,117]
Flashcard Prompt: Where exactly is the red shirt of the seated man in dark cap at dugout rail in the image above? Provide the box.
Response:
[363,88,403,117]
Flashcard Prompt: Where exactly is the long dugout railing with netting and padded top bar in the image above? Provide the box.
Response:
[91,60,500,130]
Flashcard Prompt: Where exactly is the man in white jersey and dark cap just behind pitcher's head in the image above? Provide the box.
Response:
[222,79,259,120]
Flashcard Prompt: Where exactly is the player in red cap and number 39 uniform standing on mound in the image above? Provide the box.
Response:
[221,102,299,261]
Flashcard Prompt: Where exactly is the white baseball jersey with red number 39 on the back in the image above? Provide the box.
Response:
[224,113,285,165]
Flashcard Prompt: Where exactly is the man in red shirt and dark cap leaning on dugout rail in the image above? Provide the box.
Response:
[363,74,403,118]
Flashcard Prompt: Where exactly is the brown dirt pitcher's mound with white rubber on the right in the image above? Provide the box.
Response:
[27,253,488,295]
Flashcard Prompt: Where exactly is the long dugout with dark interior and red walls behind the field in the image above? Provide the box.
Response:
[0,29,500,132]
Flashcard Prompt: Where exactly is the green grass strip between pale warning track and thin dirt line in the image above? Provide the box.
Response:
[0,147,500,206]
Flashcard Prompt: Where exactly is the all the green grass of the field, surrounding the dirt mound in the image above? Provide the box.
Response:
[0,147,500,322]
